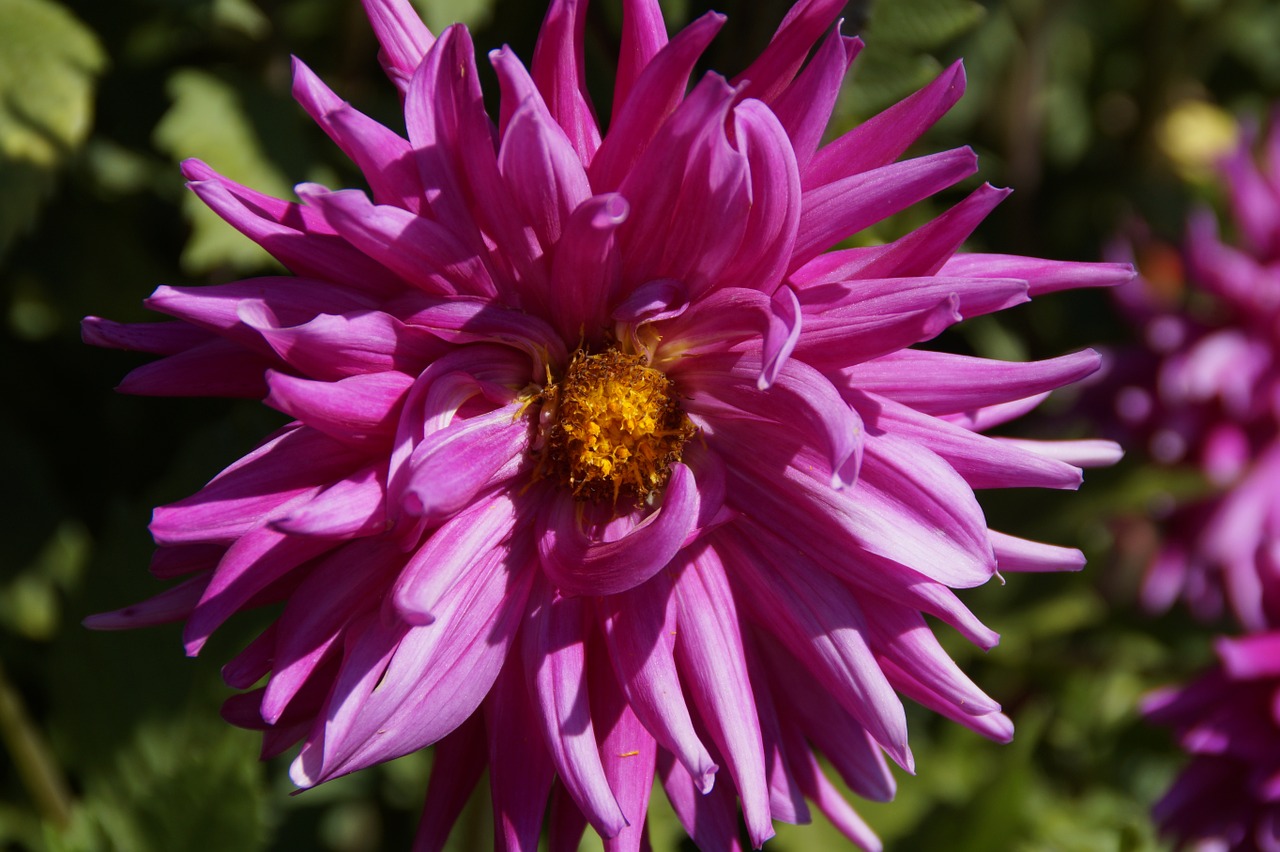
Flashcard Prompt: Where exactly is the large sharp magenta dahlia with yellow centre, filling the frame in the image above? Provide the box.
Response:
[84,0,1130,849]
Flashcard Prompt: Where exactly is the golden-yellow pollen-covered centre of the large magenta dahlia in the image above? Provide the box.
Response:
[535,348,696,504]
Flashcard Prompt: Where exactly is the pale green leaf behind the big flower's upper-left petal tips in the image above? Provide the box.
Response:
[155,69,292,274]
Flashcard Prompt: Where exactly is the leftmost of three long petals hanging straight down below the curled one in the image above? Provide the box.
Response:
[521,581,627,837]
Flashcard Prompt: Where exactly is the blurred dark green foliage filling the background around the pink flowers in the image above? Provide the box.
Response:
[0,0,1280,852]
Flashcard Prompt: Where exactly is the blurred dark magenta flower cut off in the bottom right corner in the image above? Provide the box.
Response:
[1143,631,1280,852]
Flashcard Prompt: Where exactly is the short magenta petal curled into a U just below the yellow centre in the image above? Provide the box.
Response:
[538,464,699,595]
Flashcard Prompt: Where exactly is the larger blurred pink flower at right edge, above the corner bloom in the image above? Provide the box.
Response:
[1116,111,1280,631]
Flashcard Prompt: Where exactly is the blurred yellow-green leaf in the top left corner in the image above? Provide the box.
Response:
[0,0,105,257]
